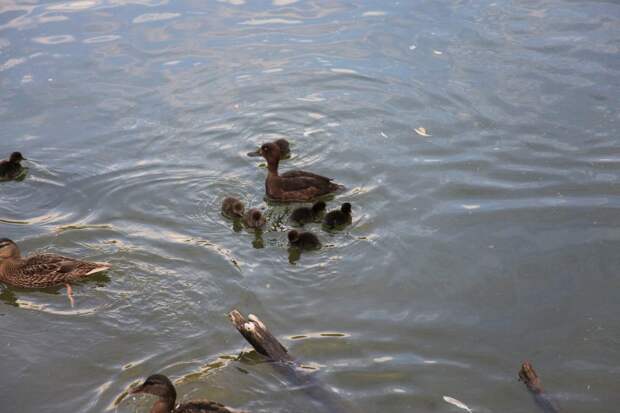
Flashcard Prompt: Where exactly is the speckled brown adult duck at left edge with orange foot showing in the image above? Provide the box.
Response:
[0,238,111,306]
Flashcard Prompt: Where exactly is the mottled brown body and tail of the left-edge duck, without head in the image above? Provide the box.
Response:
[11,254,110,288]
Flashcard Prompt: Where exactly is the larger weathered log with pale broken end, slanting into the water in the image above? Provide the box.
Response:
[228,310,355,413]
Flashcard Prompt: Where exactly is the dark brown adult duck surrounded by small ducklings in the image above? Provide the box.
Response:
[260,143,342,202]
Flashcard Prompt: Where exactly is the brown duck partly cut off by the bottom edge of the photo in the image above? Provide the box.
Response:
[129,374,244,413]
